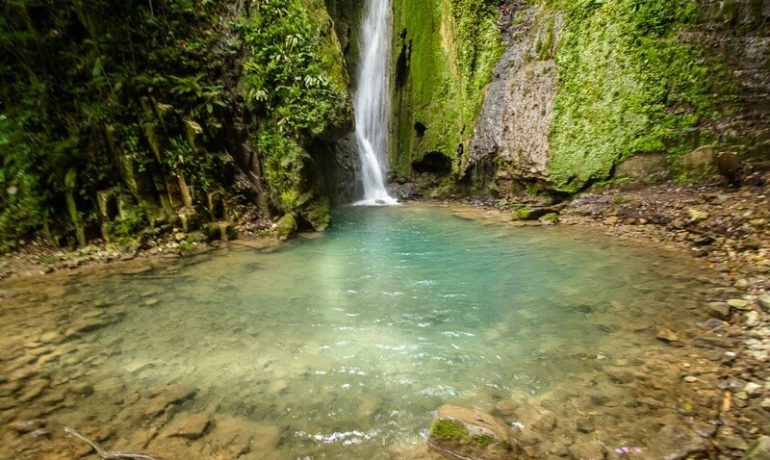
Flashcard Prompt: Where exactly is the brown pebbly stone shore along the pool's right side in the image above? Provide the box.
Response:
[436,175,770,459]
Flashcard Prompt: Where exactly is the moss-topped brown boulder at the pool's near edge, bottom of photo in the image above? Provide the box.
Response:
[428,405,520,460]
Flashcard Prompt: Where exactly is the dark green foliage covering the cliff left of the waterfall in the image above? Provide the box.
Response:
[0,0,352,250]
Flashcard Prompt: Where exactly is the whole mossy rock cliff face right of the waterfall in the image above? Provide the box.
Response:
[392,0,770,196]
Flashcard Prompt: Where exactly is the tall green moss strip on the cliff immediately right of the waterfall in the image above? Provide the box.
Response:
[391,0,502,175]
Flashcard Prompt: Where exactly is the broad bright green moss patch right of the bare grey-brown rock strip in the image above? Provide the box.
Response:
[544,0,735,192]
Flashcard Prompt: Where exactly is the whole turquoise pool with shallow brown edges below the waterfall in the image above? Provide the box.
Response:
[0,205,710,458]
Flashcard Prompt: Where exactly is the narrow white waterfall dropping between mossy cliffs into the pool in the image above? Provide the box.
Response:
[354,0,398,206]
